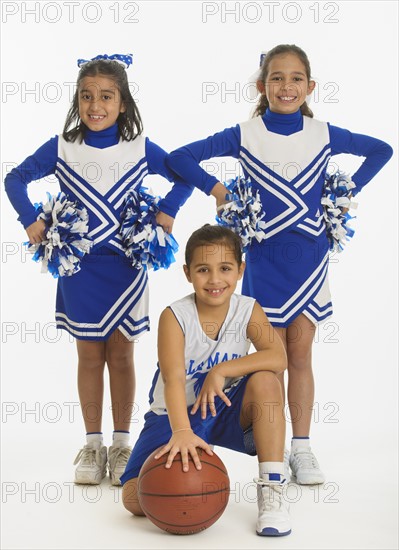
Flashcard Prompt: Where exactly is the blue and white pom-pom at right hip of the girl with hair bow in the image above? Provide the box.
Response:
[120,187,179,271]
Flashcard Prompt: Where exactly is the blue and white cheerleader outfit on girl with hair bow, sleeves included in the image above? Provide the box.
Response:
[5,124,192,341]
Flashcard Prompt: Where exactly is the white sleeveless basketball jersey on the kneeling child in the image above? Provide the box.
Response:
[150,294,255,414]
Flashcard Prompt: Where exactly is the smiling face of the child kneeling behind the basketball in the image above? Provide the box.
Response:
[184,243,245,306]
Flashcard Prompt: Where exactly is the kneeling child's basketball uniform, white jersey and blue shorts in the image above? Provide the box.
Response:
[121,294,256,484]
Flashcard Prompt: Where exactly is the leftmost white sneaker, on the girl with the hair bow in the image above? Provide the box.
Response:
[74,445,107,485]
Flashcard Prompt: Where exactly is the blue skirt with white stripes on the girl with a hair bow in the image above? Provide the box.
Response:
[56,254,149,341]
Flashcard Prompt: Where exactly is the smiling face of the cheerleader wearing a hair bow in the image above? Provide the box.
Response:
[78,75,125,132]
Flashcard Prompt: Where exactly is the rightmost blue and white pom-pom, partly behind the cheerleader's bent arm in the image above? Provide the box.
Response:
[321,170,357,252]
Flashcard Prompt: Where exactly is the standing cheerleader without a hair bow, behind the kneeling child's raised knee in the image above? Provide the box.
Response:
[168,45,392,485]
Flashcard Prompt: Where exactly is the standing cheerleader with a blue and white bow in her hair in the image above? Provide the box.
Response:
[5,54,191,485]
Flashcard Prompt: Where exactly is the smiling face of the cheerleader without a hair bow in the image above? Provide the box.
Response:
[258,53,316,114]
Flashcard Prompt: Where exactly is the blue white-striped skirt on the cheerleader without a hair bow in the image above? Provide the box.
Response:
[242,231,333,327]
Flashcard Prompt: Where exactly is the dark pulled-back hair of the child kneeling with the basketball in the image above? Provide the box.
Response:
[185,223,242,267]
